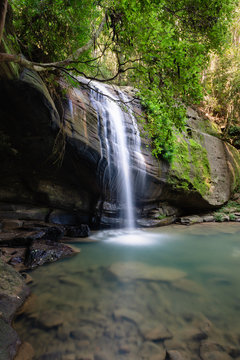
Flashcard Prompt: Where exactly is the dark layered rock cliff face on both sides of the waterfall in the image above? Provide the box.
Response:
[0,70,240,225]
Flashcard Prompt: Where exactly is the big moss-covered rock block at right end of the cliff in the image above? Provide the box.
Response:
[168,113,240,207]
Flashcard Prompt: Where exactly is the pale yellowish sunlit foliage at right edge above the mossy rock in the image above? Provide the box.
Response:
[204,4,240,138]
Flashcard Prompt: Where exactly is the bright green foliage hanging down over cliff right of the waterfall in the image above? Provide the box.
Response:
[107,0,237,160]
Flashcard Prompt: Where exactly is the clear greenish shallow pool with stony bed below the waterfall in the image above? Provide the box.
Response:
[15,223,240,360]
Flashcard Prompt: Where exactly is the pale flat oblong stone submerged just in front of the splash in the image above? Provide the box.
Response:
[108,262,186,282]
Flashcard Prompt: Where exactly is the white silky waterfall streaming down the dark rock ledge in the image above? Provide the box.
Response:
[90,81,145,229]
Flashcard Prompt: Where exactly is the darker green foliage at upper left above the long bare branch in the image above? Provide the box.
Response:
[11,0,98,61]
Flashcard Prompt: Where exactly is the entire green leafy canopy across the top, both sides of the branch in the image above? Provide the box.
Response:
[9,0,238,159]
